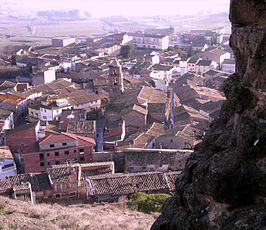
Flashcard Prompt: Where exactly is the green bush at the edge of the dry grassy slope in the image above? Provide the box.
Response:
[127,192,171,213]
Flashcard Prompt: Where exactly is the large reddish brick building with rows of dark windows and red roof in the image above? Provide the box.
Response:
[20,133,95,173]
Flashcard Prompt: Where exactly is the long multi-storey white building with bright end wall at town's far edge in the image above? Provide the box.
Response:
[133,33,170,50]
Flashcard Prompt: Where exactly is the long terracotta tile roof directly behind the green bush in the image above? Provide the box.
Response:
[86,172,180,196]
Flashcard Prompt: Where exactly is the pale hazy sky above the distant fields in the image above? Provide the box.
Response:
[0,0,230,17]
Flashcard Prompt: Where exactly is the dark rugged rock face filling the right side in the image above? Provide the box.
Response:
[152,0,266,230]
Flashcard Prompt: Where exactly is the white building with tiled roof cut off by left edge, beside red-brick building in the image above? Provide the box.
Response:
[0,146,17,179]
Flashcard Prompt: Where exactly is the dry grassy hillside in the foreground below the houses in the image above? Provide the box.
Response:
[0,197,156,230]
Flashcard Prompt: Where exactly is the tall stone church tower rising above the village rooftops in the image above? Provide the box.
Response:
[109,59,124,94]
